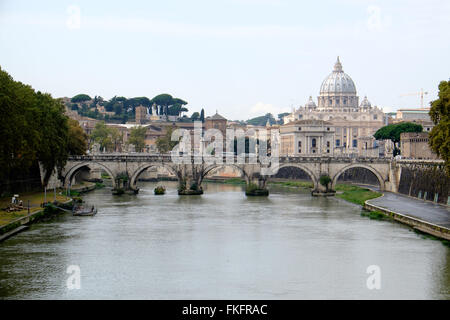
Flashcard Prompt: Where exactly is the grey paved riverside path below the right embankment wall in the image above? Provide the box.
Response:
[368,192,450,229]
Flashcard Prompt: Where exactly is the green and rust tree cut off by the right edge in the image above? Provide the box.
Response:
[429,81,450,175]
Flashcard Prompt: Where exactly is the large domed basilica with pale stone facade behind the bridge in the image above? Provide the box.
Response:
[280,57,385,155]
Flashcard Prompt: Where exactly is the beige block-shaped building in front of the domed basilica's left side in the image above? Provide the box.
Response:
[280,120,335,156]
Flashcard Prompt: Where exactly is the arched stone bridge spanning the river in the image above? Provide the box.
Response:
[56,154,442,194]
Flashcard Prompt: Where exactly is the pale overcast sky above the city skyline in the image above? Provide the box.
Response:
[0,0,450,120]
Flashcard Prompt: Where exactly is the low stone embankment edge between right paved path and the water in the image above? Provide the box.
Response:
[364,200,450,241]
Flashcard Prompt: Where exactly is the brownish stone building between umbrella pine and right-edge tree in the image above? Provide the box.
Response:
[400,132,439,159]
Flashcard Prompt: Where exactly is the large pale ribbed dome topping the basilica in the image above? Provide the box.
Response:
[320,57,356,95]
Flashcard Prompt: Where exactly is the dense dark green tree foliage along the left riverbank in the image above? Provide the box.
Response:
[0,68,69,192]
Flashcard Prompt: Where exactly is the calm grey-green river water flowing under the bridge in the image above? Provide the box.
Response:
[0,182,450,299]
